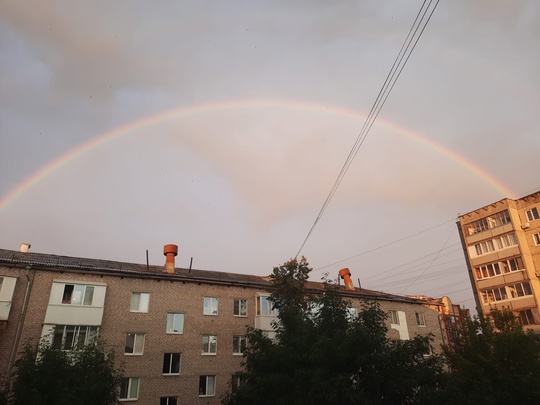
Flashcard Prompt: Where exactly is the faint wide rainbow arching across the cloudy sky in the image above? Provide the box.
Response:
[0,99,516,211]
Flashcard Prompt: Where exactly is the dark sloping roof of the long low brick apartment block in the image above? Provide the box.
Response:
[0,249,430,305]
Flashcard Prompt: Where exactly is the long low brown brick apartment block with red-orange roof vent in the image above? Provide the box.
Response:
[0,245,444,405]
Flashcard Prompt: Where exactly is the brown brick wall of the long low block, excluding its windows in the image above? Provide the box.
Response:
[0,267,442,405]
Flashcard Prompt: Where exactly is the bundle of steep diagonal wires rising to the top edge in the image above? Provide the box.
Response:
[295,0,439,258]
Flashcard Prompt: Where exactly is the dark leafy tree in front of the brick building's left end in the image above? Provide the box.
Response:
[5,341,122,405]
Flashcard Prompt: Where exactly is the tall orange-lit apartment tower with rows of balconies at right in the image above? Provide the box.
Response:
[457,191,540,334]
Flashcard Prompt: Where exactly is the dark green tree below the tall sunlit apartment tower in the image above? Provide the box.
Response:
[445,309,540,404]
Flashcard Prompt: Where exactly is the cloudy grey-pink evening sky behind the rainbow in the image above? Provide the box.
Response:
[0,0,540,308]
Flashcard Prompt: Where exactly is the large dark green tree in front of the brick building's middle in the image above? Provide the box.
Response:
[223,258,443,405]
